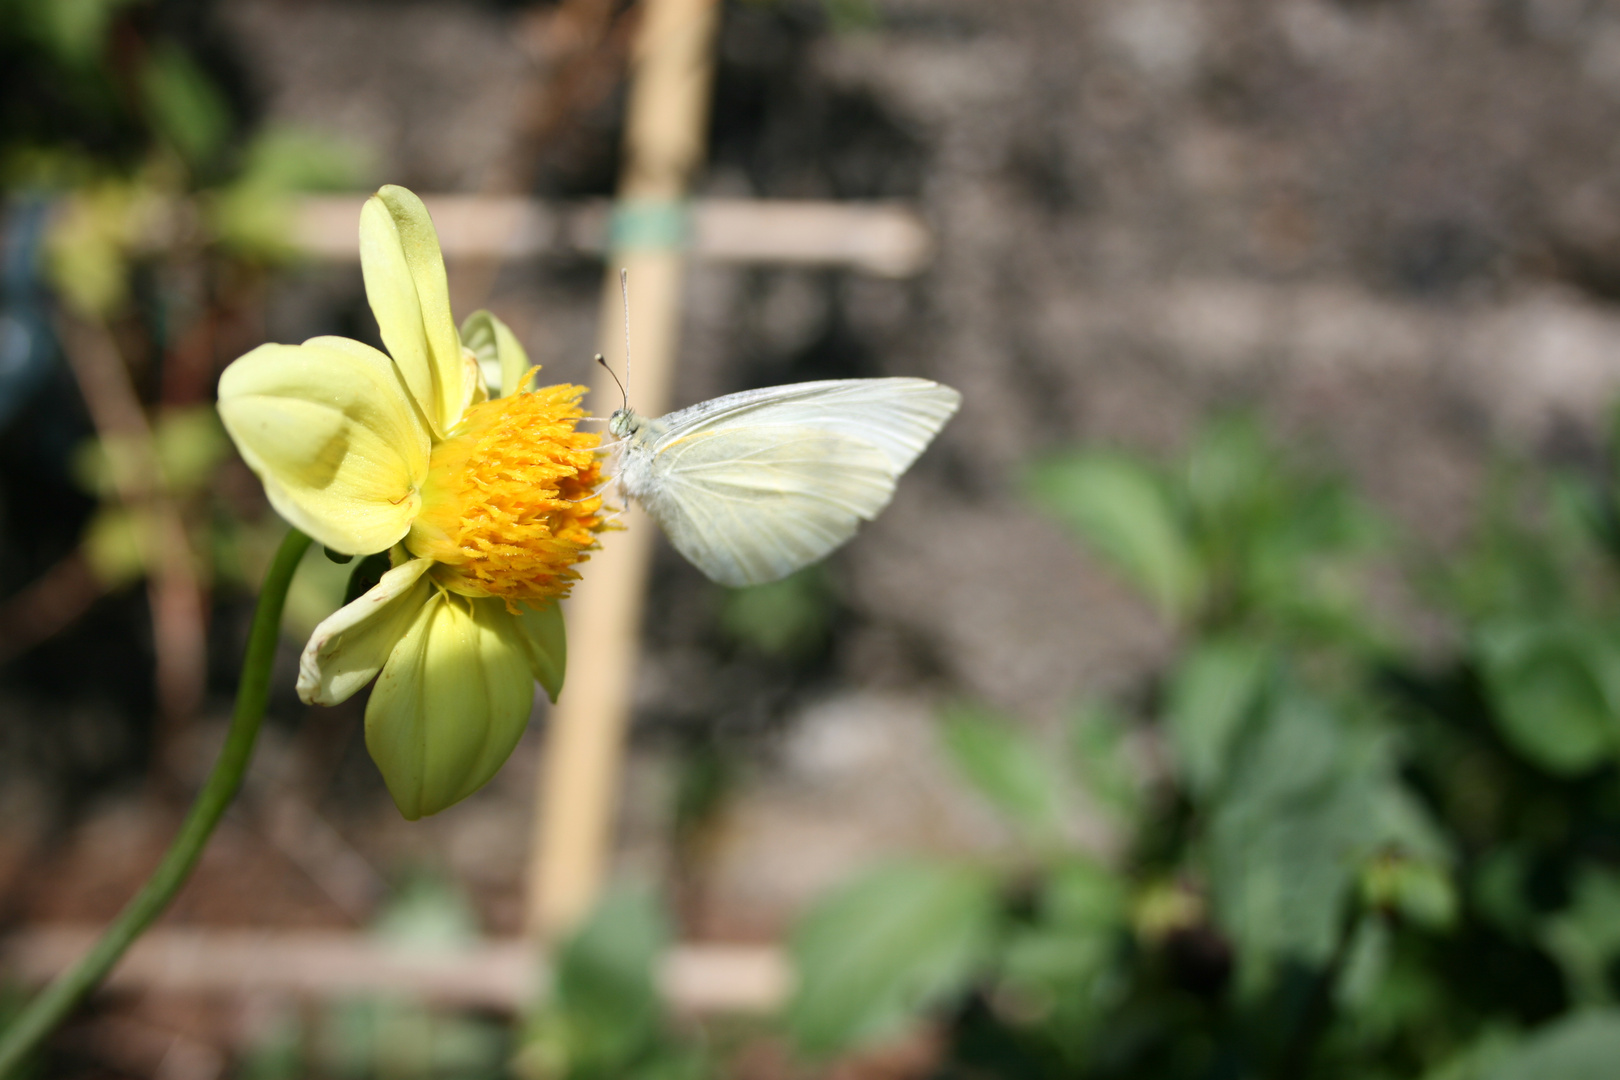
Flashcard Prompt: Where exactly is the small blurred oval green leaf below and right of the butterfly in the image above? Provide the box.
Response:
[941,704,1063,832]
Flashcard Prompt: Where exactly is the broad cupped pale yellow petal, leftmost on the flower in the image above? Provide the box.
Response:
[219,338,431,555]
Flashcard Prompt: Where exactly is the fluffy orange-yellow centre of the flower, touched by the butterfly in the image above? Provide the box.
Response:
[405,369,604,610]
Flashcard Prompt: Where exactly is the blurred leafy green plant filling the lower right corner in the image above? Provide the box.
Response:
[786,421,1620,1080]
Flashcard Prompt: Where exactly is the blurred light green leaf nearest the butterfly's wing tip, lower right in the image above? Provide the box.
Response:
[1029,453,1202,617]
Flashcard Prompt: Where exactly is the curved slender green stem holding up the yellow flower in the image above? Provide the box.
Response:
[0,529,309,1077]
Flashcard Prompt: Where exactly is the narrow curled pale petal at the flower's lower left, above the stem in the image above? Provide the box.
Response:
[298,559,433,704]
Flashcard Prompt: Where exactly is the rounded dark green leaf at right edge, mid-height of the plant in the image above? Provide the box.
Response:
[1476,622,1617,776]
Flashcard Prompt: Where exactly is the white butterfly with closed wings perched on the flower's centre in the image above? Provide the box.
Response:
[608,379,962,586]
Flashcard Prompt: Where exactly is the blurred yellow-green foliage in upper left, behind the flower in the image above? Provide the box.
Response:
[0,0,366,641]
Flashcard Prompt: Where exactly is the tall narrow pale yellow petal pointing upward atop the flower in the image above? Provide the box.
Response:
[360,185,468,436]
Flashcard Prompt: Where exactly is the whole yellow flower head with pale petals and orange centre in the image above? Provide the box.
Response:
[219,186,604,819]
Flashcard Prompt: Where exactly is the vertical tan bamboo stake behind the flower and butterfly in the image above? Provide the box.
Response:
[528,0,719,939]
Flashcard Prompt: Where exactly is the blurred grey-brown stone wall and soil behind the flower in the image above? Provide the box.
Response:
[9,0,1620,1075]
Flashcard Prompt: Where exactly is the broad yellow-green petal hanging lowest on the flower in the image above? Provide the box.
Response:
[366,593,535,821]
